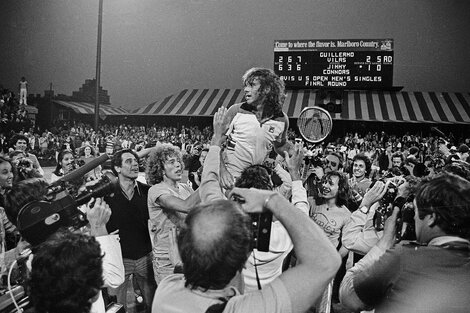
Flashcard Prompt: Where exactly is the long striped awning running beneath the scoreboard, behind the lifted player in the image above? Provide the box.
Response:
[133,89,470,124]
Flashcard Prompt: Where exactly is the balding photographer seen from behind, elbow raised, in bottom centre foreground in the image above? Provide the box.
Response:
[152,188,340,312]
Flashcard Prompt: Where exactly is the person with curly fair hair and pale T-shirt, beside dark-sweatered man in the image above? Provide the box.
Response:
[147,144,200,284]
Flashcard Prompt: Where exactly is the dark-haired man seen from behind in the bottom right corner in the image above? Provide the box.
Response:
[340,174,470,312]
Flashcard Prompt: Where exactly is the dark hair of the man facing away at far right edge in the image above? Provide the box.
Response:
[415,173,470,239]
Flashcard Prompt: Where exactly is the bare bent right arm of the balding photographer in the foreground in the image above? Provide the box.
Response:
[231,188,341,313]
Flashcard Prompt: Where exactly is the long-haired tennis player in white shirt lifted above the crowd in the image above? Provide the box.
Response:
[220,68,291,189]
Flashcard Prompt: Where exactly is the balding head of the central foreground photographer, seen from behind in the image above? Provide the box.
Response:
[178,200,252,290]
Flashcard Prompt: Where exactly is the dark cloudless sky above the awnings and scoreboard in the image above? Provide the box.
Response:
[0,0,470,109]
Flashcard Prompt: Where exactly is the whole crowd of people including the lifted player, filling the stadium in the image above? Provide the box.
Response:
[0,68,470,313]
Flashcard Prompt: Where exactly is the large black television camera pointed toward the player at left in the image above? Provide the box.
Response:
[0,154,122,312]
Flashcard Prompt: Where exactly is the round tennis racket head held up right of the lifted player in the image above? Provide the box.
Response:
[297,106,333,143]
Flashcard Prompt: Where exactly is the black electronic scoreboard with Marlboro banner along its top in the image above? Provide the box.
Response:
[274,39,393,89]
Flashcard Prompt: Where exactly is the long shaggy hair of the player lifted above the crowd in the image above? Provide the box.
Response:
[242,67,286,118]
